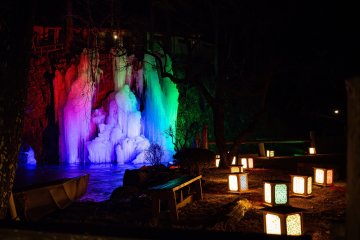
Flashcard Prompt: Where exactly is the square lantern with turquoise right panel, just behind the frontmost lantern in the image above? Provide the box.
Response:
[263,180,289,206]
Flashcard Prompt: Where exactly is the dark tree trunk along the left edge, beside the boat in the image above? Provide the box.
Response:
[0,0,33,219]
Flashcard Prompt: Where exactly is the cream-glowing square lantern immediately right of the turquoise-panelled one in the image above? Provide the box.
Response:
[290,175,312,197]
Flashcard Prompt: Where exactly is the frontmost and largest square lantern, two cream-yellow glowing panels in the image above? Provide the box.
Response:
[262,206,304,236]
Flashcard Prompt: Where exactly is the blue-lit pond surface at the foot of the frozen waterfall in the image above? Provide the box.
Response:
[14,164,144,202]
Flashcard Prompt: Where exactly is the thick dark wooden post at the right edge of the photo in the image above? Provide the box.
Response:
[346,77,360,239]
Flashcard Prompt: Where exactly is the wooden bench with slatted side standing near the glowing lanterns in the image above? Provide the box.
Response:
[149,175,203,222]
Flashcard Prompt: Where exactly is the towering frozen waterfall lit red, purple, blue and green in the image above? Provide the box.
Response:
[59,44,179,164]
